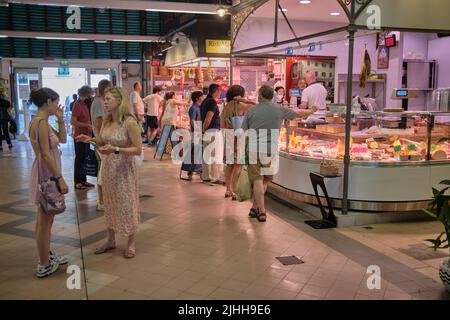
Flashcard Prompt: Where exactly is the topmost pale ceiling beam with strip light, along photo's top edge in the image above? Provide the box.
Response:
[8,0,230,14]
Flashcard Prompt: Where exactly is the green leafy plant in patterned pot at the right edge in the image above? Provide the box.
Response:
[423,180,450,292]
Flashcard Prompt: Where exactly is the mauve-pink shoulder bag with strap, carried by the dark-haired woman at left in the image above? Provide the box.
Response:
[36,119,66,214]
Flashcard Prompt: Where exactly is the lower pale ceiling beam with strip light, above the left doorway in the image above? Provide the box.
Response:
[0,30,160,42]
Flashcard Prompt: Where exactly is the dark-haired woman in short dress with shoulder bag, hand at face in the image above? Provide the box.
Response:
[29,88,69,278]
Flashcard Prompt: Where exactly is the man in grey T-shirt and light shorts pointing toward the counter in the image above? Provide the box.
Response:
[242,85,317,222]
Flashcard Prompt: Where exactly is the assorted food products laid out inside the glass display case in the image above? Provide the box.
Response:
[279,112,450,162]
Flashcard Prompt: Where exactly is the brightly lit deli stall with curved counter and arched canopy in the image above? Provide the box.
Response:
[232,0,450,214]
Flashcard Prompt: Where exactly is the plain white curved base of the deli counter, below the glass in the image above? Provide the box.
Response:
[273,152,450,212]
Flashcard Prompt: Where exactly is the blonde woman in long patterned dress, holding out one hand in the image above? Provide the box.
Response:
[76,87,142,259]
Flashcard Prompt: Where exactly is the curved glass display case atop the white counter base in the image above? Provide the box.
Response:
[279,111,450,163]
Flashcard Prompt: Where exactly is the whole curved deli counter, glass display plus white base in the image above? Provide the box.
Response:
[271,112,450,212]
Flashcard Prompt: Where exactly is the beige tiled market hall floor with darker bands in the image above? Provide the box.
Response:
[0,142,450,300]
